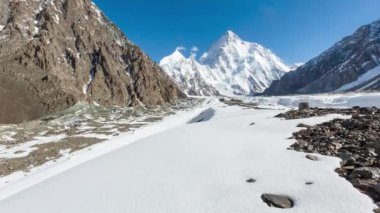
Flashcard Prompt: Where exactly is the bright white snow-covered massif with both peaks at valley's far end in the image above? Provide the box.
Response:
[160,31,291,95]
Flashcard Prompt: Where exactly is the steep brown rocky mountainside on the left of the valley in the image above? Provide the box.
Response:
[0,0,183,123]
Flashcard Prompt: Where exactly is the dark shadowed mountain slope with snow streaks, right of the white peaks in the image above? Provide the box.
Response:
[264,20,380,95]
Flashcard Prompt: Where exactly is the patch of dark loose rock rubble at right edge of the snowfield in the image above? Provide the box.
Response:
[286,107,380,207]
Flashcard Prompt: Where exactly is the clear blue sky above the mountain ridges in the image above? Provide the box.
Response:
[94,0,380,64]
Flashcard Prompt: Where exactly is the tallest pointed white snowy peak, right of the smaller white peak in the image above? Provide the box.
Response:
[200,31,290,95]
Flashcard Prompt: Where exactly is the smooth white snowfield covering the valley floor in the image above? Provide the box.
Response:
[0,94,380,213]
